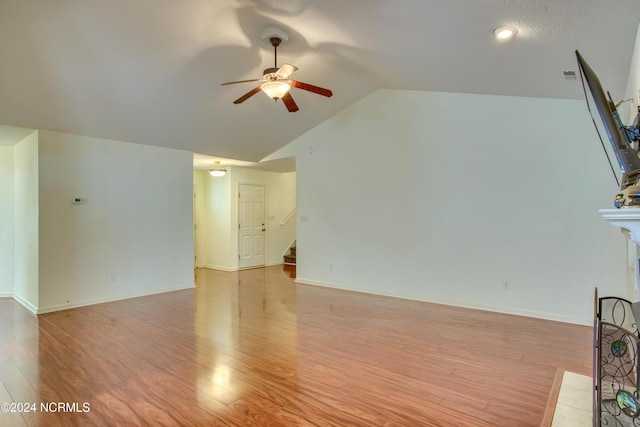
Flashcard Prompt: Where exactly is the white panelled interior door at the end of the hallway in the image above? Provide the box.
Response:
[238,184,266,268]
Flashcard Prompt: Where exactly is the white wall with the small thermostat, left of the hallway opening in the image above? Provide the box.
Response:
[38,131,194,312]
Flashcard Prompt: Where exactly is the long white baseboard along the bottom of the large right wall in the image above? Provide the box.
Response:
[295,277,593,326]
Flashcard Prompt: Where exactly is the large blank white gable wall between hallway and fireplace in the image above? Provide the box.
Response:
[271,91,628,324]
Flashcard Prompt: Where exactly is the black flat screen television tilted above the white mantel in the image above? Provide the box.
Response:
[576,50,640,196]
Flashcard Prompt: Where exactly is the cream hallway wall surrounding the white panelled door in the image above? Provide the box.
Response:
[194,167,296,271]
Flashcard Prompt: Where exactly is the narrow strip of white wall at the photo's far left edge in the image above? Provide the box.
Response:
[0,146,15,297]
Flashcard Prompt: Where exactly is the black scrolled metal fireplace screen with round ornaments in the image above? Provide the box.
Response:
[593,289,640,427]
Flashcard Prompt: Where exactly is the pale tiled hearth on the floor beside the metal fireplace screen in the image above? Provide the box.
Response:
[551,371,593,427]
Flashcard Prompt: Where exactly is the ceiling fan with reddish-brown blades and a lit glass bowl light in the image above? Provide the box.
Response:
[222,29,333,113]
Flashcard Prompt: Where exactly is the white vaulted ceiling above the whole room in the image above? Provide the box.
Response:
[0,0,640,167]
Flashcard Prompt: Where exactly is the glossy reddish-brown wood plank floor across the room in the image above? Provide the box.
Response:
[0,266,592,427]
